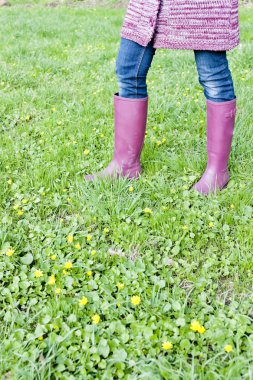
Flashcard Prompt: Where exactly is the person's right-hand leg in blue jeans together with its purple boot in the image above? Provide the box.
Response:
[193,50,236,195]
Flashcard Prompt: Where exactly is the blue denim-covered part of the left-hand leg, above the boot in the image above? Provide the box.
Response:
[116,38,156,98]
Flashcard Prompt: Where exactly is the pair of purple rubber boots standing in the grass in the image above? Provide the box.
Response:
[85,93,236,195]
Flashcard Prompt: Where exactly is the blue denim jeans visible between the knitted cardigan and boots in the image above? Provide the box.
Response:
[116,37,236,102]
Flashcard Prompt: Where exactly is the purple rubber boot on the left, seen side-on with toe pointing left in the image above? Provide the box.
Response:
[85,93,148,181]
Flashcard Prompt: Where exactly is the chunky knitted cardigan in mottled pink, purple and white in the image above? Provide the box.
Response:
[120,0,239,50]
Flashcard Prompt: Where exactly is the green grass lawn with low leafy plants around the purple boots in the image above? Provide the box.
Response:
[0,2,253,380]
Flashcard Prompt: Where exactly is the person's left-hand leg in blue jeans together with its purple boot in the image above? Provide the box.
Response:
[85,38,155,181]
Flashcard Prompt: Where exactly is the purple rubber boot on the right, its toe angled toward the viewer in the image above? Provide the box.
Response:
[192,99,236,195]
